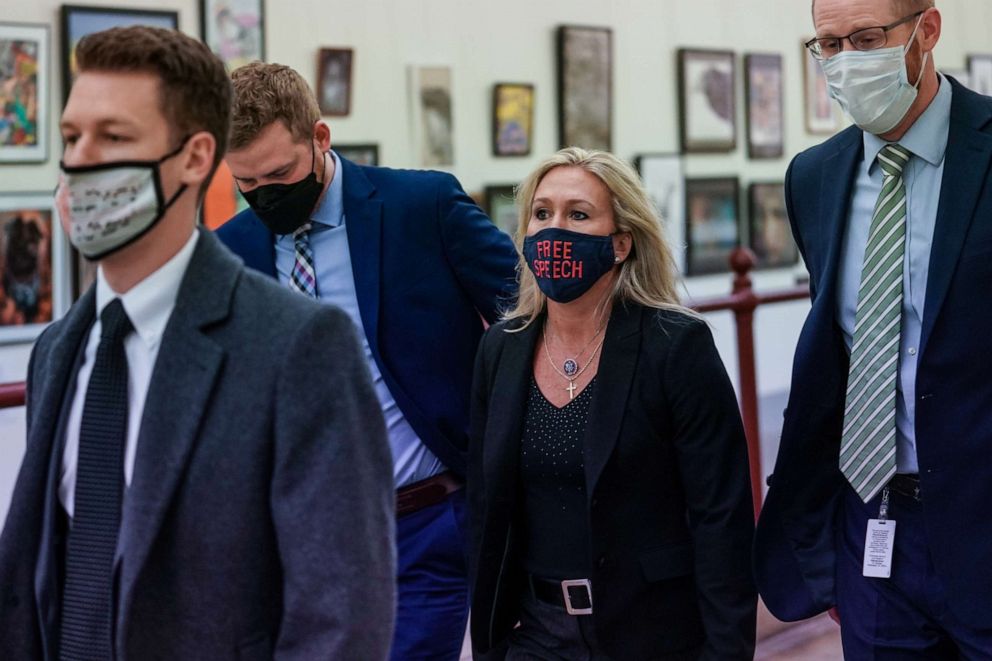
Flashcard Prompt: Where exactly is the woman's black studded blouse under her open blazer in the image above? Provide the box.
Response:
[520,377,596,580]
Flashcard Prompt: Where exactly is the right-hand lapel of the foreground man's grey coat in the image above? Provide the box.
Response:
[117,231,232,631]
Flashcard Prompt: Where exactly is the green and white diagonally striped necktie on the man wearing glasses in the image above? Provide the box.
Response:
[840,145,912,502]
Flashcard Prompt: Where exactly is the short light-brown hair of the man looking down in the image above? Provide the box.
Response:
[231,62,320,149]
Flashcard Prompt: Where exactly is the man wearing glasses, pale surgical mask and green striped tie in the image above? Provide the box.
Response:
[755,0,992,659]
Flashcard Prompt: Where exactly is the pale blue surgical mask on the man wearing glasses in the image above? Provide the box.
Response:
[820,16,930,135]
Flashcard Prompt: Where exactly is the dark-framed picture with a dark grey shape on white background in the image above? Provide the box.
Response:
[678,48,737,153]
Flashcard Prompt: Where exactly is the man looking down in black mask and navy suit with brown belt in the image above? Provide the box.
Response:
[218,63,517,659]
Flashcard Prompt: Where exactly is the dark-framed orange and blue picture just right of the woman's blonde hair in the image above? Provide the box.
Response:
[685,177,741,276]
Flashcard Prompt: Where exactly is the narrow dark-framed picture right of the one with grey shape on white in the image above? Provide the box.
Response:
[744,54,785,158]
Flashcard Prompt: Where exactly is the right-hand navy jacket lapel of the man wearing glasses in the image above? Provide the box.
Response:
[920,83,992,355]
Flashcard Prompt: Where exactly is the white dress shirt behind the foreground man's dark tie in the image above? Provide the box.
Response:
[59,231,200,517]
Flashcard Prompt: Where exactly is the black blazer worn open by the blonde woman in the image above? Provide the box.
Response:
[468,303,757,660]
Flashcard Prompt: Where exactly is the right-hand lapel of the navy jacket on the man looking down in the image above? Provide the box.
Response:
[339,158,382,351]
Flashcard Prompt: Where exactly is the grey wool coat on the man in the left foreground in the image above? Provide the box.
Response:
[0,230,395,661]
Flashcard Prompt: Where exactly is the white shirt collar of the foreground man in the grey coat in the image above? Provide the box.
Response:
[96,230,200,350]
